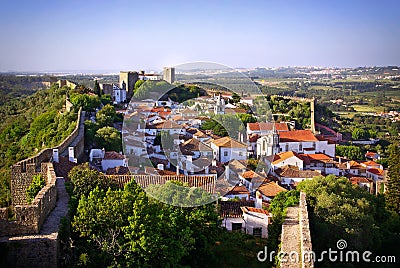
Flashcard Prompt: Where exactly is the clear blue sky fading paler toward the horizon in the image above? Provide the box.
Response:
[0,0,400,71]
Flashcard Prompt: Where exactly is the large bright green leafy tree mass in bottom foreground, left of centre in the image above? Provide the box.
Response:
[72,180,220,267]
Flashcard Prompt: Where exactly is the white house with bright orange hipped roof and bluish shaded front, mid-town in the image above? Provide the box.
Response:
[210,137,247,163]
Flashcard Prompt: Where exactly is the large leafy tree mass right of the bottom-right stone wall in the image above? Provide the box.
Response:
[297,175,399,256]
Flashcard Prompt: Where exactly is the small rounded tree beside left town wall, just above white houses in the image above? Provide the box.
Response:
[94,126,122,152]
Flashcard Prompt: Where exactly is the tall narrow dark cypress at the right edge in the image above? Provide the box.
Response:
[385,144,400,214]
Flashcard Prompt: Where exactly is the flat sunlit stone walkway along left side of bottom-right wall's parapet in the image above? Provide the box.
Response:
[281,206,301,268]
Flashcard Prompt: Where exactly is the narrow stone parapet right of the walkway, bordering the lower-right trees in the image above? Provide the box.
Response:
[299,192,314,268]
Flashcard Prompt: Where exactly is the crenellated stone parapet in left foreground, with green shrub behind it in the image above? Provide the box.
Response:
[0,163,57,236]
